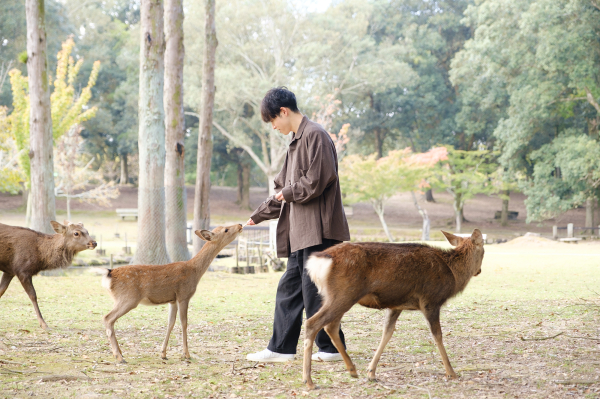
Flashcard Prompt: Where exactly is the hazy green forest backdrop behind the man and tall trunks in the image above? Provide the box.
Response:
[0,0,600,236]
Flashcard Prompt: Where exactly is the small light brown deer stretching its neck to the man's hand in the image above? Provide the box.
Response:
[102,224,243,363]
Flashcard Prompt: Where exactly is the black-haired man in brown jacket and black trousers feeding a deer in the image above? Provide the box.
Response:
[247,87,350,362]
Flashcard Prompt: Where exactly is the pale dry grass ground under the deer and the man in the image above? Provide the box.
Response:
[0,238,600,398]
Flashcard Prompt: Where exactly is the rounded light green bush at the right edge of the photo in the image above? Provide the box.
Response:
[522,134,600,221]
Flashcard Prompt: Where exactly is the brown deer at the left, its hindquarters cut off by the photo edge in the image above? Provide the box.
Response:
[0,220,97,330]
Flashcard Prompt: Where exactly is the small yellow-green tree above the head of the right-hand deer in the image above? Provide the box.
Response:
[432,147,497,233]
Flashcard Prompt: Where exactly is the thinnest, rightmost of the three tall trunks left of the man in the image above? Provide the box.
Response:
[194,0,218,253]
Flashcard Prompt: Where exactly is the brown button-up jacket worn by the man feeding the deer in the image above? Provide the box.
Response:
[250,116,350,258]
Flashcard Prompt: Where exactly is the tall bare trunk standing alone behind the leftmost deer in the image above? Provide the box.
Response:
[25,0,56,234]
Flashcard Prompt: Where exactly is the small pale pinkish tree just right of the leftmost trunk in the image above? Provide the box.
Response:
[55,125,119,220]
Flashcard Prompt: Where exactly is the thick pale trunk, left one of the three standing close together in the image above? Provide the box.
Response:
[132,0,169,265]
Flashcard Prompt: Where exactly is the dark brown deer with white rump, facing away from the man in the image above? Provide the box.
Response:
[302,229,484,389]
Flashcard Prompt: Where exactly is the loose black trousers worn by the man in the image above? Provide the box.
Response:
[267,238,346,354]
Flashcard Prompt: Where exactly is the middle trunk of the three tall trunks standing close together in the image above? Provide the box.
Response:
[164,0,190,262]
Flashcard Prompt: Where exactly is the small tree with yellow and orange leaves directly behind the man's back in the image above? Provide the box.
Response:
[340,149,420,242]
